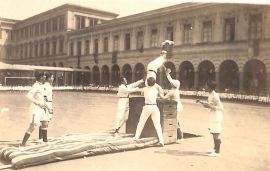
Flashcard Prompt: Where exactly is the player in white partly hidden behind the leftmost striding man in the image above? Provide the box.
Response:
[39,73,54,142]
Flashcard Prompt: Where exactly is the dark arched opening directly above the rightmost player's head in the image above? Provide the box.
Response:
[197,61,215,90]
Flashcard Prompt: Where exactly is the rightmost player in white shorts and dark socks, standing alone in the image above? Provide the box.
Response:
[196,81,224,157]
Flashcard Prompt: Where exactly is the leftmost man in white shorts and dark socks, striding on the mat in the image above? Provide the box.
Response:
[19,71,48,151]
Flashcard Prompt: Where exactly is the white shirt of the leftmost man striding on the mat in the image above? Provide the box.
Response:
[26,81,45,105]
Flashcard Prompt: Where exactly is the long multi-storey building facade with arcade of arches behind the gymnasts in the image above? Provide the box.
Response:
[0,3,270,94]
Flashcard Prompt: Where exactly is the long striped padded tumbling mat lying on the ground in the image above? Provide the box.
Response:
[0,132,158,169]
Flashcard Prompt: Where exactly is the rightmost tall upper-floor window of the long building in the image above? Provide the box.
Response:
[249,14,262,39]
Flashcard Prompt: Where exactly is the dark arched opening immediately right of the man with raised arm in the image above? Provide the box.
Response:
[179,61,194,90]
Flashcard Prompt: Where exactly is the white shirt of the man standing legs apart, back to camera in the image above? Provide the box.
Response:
[143,84,163,104]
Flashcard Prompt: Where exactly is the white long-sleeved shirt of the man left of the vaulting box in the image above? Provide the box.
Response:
[117,80,143,97]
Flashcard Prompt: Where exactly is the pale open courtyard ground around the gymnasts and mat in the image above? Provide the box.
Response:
[0,91,270,171]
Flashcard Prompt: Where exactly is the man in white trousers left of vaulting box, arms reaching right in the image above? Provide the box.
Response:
[114,77,144,136]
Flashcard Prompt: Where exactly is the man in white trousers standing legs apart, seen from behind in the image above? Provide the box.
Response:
[134,77,164,147]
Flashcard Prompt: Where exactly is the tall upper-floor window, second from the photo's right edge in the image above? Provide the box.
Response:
[224,18,235,41]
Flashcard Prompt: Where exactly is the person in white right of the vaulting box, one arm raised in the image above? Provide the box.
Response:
[163,68,184,143]
